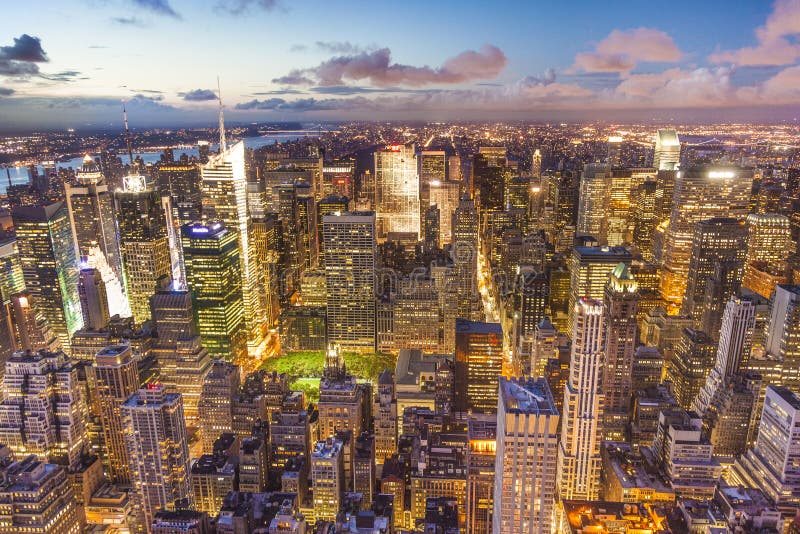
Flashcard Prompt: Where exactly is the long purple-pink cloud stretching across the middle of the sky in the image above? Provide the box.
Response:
[273,45,508,87]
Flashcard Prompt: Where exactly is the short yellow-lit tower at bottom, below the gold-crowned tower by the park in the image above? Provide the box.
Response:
[311,438,346,522]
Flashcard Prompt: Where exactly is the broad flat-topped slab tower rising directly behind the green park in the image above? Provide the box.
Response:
[322,212,376,351]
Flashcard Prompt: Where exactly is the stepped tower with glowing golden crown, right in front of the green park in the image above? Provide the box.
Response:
[317,348,370,438]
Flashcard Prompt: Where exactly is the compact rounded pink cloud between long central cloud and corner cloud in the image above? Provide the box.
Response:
[573,28,681,72]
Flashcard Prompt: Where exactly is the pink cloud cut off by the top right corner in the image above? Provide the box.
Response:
[709,0,800,66]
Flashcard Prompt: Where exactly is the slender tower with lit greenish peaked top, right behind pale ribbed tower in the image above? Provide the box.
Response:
[602,263,639,441]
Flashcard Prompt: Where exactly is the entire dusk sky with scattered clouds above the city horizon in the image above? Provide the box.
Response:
[0,0,800,130]
